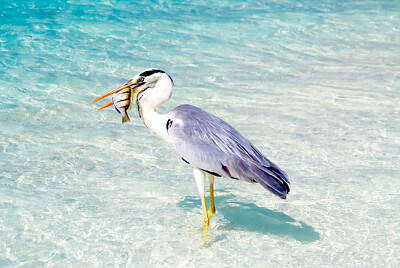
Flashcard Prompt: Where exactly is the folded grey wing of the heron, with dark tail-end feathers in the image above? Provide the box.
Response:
[167,105,290,198]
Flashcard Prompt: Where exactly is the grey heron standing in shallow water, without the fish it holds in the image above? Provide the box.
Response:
[94,69,290,226]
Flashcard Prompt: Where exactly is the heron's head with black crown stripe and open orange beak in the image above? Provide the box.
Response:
[93,68,173,110]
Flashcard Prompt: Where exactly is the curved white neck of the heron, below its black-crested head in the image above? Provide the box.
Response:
[137,74,173,143]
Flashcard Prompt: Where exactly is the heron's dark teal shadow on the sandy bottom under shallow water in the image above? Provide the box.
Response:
[178,194,320,243]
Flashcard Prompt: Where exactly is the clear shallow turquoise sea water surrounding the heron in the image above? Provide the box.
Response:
[0,0,400,267]
